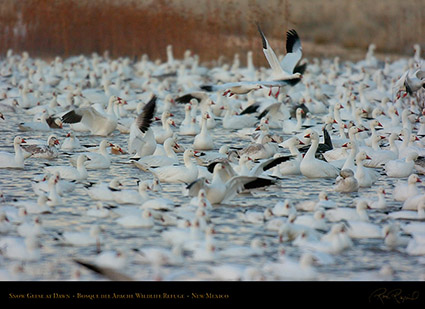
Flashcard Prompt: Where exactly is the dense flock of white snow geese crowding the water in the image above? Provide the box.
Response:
[0,26,425,280]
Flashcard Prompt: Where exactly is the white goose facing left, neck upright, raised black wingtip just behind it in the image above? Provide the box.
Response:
[300,130,339,178]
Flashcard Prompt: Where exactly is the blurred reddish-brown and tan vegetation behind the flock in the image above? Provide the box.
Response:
[0,0,425,64]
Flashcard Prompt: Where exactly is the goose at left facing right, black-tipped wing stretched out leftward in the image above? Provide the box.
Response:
[61,96,119,136]
